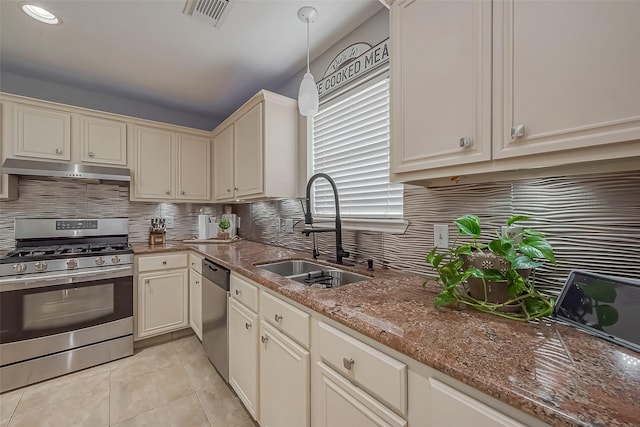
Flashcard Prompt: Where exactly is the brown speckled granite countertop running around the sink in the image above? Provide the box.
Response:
[134,241,640,427]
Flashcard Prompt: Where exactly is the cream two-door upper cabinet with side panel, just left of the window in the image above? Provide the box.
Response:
[213,90,298,201]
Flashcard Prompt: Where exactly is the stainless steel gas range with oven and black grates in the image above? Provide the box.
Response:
[0,218,133,392]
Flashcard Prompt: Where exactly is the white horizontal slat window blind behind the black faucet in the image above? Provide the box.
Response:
[312,77,403,218]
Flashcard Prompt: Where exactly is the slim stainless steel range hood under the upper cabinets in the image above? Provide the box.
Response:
[2,158,131,185]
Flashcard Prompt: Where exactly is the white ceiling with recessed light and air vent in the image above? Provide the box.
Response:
[0,0,383,125]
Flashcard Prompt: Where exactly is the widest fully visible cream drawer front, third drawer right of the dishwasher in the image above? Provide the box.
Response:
[314,322,407,415]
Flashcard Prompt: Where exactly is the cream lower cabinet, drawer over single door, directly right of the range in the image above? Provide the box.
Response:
[135,252,189,339]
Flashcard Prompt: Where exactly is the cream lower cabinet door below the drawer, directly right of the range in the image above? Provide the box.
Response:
[138,269,189,338]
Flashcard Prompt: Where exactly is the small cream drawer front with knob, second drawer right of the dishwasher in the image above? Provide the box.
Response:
[260,292,310,348]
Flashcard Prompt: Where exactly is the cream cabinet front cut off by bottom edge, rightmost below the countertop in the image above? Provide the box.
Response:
[425,378,524,427]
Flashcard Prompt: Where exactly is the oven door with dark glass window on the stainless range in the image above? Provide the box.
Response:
[0,266,133,344]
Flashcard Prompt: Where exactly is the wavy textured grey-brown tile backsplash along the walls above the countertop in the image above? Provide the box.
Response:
[0,171,640,293]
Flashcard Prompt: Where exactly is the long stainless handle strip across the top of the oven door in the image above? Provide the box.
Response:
[0,265,133,292]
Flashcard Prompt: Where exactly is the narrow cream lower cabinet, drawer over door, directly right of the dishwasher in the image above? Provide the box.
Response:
[229,273,268,420]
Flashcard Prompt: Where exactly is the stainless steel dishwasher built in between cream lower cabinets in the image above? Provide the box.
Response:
[202,259,230,382]
